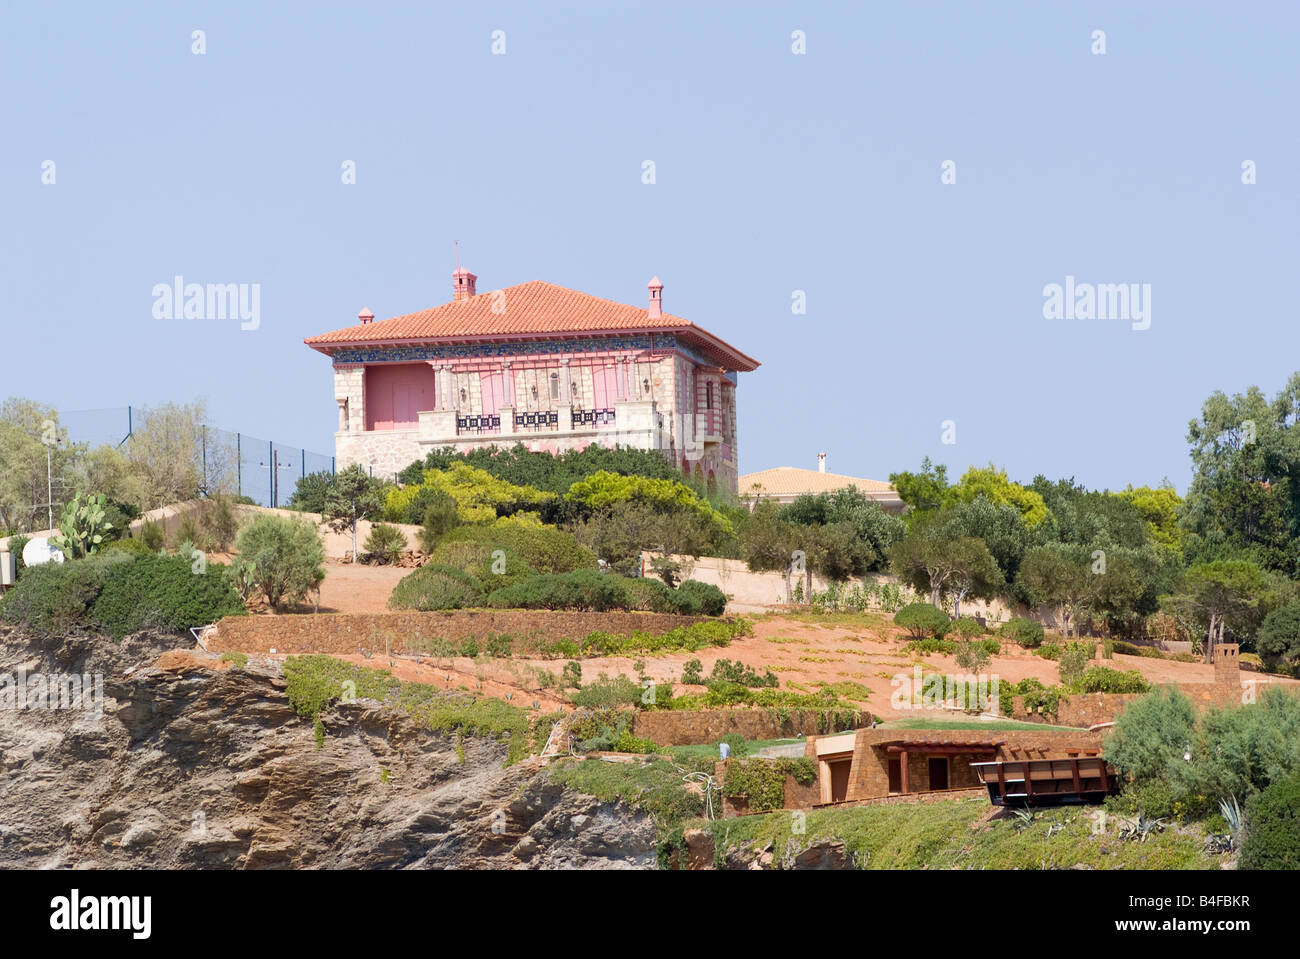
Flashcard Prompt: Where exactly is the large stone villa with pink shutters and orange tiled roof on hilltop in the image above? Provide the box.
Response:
[304,268,759,491]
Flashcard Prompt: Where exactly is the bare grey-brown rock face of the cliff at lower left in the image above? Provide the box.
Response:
[0,626,655,869]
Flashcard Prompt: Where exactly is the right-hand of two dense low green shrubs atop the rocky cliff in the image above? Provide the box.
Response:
[94,554,246,639]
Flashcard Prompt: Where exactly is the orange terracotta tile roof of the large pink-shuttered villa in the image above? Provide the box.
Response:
[303,279,758,370]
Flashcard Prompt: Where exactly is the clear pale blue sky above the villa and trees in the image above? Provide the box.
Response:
[0,1,1300,490]
